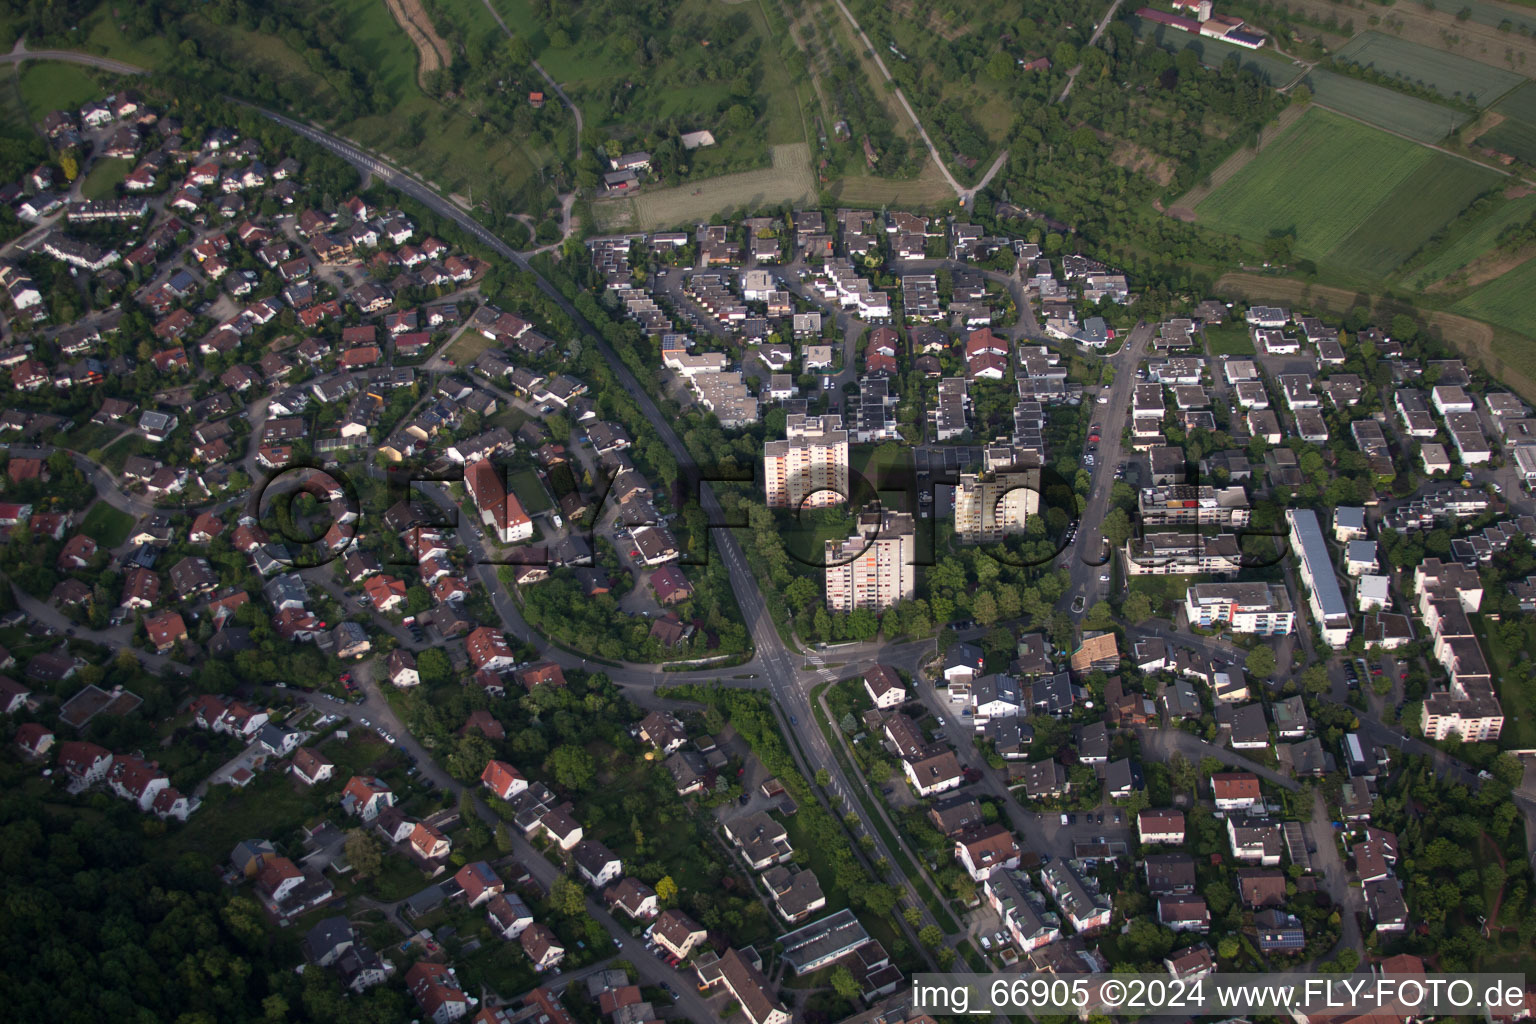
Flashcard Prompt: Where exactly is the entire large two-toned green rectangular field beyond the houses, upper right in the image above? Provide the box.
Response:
[1197,109,1462,273]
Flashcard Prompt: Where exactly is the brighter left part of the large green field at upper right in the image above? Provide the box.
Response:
[1198,109,1437,270]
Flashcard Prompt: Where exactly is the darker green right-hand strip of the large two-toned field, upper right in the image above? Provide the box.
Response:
[1327,154,1504,276]
